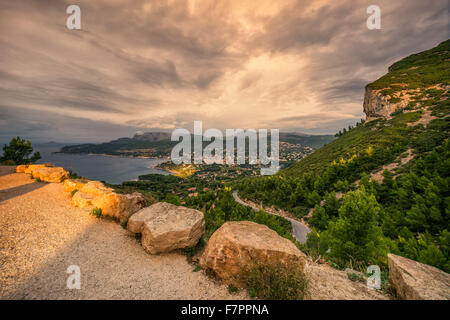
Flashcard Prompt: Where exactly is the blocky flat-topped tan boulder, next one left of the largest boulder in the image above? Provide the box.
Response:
[127,202,205,254]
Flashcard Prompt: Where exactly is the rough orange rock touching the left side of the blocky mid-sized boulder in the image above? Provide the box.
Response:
[92,189,145,223]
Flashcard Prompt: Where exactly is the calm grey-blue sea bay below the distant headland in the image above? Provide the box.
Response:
[34,144,170,184]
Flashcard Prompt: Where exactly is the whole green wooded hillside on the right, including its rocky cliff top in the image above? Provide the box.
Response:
[234,40,450,272]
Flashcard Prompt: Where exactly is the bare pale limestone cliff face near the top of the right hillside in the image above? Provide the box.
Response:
[363,87,409,119]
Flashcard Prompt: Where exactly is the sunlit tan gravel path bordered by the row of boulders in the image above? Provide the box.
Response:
[0,167,247,299]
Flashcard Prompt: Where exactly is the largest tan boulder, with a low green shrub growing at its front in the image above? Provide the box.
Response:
[200,221,306,281]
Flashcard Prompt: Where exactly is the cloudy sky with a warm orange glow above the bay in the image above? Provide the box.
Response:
[0,0,449,142]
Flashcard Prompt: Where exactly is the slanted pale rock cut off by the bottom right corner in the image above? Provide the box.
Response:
[388,253,450,300]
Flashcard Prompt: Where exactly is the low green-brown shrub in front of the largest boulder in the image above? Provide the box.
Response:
[236,260,308,300]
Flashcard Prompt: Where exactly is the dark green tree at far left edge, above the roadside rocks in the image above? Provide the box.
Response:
[0,137,41,164]
